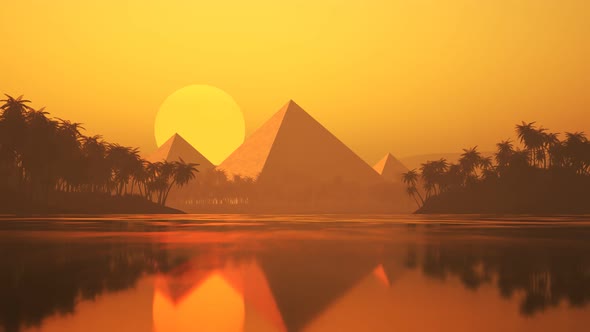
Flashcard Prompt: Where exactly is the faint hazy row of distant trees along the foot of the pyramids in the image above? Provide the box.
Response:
[168,169,413,213]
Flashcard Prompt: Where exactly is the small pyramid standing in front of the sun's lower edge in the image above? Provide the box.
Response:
[146,134,215,172]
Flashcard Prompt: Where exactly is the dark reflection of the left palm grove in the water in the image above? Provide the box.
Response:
[0,238,183,331]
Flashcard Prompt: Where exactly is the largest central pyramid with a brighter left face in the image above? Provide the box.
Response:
[219,101,383,185]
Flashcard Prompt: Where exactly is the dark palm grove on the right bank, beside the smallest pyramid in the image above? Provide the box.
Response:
[403,122,590,213]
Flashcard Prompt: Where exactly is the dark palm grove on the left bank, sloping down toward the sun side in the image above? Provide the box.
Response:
[0,95,198,213]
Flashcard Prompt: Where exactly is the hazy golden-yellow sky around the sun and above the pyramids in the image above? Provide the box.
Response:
[0,0,590,163]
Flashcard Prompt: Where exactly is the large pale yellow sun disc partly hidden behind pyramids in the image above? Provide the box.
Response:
[154,85,245,165]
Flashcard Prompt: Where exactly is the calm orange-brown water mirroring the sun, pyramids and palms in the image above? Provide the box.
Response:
[0,215,590,332]
